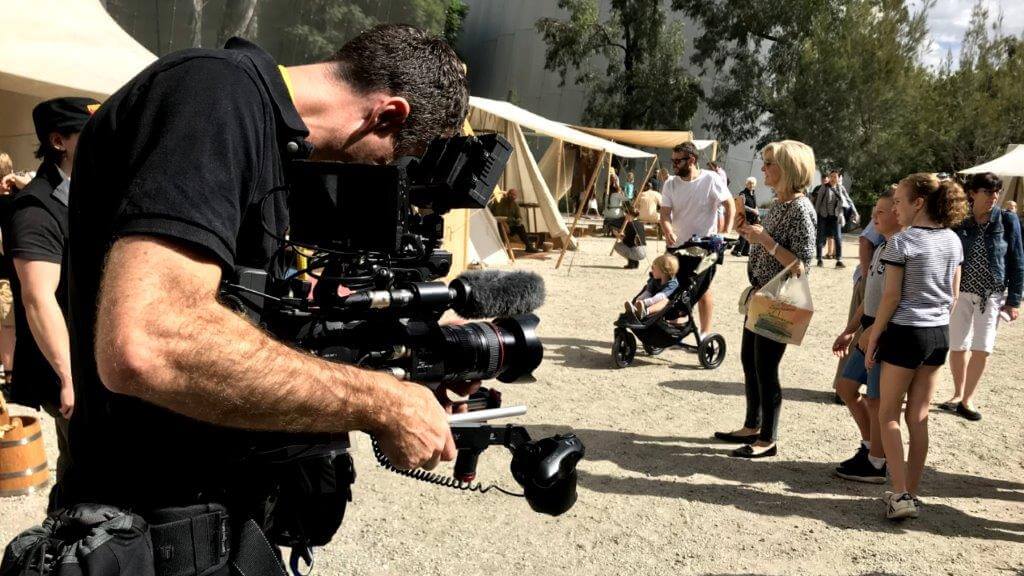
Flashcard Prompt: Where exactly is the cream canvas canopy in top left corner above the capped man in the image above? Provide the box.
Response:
[0,0,156,170]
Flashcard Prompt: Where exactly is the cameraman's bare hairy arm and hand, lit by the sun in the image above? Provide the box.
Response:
[95,236,455,467]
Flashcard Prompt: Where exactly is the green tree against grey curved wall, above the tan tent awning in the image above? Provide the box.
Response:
[537,0,700,129]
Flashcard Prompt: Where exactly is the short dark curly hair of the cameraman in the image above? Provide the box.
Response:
[331,25,469,155]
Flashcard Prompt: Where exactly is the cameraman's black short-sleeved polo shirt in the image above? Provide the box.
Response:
[65,39,311,509]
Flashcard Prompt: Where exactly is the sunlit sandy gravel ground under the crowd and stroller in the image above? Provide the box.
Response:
[0,239,1024,576]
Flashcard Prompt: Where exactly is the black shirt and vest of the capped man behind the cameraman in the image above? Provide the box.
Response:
[3,158,68,409]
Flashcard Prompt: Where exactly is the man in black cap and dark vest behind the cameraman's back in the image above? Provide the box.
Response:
[3,97,99,500]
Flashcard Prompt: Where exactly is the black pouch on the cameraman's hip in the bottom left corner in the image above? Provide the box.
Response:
[0,504,156,576]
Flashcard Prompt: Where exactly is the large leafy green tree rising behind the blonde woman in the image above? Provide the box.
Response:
[673,0,930,197]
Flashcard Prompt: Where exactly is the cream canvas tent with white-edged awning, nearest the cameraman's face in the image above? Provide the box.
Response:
[469,96,654,247]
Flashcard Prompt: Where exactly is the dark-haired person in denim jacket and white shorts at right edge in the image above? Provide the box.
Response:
[941,172,1024,420]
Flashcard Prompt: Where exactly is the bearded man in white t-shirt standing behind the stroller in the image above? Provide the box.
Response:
[662,142,735,334]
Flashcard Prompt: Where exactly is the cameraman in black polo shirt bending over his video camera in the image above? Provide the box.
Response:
[63,26,468,545]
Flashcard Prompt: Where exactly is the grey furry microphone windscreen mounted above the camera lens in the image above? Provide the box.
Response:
[456,270,545,318]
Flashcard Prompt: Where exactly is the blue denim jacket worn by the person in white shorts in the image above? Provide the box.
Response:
[953,207,1024,307]
